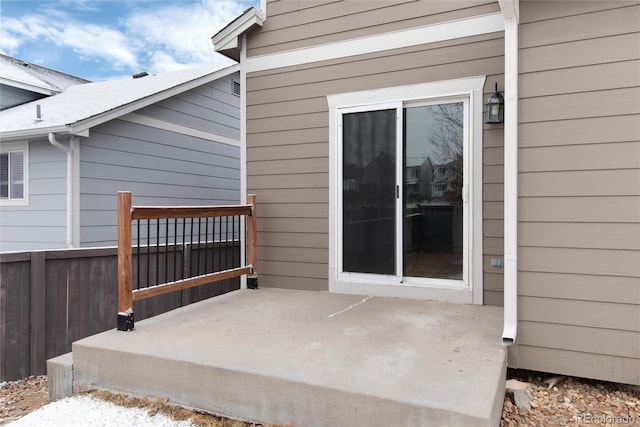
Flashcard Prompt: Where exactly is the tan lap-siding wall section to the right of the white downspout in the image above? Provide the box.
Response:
[509,1,640,384]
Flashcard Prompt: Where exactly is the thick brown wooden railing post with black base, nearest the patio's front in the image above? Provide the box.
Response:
[118,191,133,331]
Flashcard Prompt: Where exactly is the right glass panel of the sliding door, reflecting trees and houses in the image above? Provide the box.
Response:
[403,102,464,280]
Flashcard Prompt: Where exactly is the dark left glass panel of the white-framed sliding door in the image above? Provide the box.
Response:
[341,109,397,276]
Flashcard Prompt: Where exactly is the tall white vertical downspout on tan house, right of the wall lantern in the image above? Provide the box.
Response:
[499,0,519,346]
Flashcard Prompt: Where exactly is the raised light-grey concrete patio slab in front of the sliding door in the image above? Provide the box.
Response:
[73,289,506,426]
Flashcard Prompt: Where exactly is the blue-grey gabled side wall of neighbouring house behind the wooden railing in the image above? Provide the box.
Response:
[80,74,240,247]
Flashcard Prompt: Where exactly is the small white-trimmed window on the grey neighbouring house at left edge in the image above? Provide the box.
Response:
[0,143,29,205]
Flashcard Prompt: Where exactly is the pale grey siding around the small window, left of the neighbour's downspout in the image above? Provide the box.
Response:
[0,140,67,252]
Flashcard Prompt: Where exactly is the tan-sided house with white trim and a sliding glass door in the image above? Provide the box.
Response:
[213,0,640,384]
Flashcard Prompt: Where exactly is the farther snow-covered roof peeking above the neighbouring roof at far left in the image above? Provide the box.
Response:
[0,54,89,110]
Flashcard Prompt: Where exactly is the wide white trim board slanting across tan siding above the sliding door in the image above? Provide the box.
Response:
[245,12,504,73]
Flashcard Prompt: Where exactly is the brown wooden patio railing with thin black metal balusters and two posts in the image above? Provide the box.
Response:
[117,192,257,331]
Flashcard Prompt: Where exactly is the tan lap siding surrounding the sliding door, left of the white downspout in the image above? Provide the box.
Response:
[246,1,504,305]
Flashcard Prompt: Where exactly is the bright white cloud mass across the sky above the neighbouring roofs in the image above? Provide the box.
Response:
[0,0,254,78]
